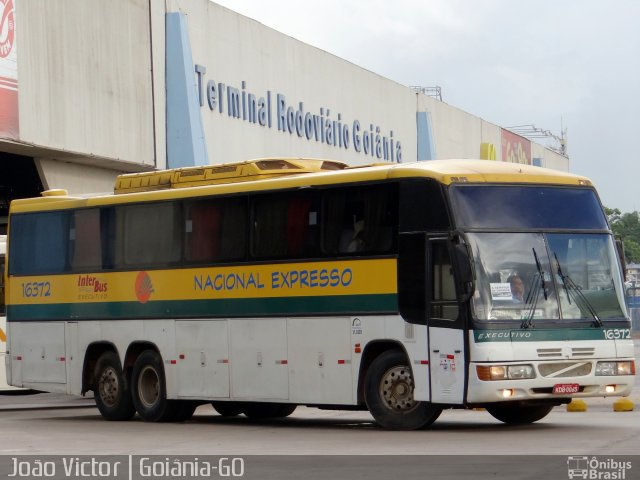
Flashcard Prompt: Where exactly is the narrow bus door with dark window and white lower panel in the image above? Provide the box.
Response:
[426,239,466,404]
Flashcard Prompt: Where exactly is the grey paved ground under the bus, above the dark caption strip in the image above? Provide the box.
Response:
[0,376,640,456]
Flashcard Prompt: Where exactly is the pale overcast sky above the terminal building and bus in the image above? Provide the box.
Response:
[216,0,640,212]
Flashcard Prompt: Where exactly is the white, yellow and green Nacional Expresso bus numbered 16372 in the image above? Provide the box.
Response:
[6,158,635,429]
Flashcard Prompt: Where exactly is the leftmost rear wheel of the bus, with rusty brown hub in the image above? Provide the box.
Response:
[94,351,136,421]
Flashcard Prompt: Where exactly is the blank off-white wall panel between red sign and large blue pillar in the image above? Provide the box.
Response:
[16,0,155,166]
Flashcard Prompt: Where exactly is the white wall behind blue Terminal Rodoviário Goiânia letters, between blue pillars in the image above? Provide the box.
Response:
[167,0,416,164]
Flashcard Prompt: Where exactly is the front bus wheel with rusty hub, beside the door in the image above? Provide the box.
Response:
[364,350,442,430]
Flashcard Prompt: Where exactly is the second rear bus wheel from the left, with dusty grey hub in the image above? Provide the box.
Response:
[131,350,178,422]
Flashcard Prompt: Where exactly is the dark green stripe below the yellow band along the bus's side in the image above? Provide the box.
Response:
[7,294,398,321]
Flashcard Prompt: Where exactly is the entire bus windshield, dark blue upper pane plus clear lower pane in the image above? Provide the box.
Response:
[452,185,625,328]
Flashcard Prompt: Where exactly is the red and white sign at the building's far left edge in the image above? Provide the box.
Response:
[0,0,18,140]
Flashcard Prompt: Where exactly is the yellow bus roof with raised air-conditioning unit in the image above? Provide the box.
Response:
[11,158,592,212]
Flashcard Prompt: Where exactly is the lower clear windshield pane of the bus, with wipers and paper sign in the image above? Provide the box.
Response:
[468,233,625,327]
